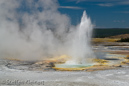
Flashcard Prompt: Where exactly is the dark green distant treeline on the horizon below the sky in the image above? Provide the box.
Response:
[93,28,129,38]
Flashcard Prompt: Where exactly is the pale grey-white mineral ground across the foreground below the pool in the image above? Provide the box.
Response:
[0,60,129,86]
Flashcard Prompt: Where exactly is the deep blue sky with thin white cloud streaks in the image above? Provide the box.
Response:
[58,0,129,28]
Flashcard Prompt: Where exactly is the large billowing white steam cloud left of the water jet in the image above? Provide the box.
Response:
[0,0,94,63]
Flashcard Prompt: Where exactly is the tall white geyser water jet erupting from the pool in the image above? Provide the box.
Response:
[66,11,95,64]
